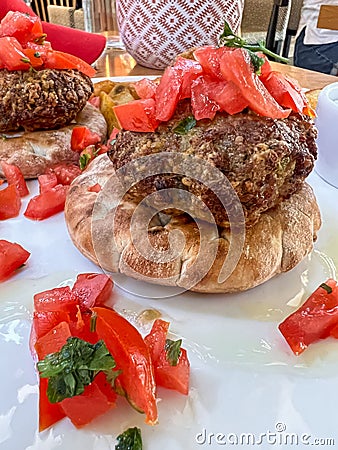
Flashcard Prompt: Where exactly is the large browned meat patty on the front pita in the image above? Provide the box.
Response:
[109,101,317,227]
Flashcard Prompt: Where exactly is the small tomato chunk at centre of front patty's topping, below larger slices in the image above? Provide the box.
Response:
[191,76,220,120]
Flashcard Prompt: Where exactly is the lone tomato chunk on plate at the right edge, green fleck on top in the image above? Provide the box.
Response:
[278,279,338,355]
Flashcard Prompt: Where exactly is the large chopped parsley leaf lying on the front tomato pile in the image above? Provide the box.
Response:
[37,337,115,403]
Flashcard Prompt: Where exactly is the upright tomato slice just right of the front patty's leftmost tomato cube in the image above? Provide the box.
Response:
[155,66,182,121]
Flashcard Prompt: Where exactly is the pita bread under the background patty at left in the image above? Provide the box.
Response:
[0,103,107,179]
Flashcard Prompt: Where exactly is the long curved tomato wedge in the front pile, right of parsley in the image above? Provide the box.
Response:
[92,307,158,425]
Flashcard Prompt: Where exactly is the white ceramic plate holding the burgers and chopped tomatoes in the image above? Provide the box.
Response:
[0,80,338,450]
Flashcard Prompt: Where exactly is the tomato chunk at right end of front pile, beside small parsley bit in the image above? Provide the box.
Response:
[144,319,190,395]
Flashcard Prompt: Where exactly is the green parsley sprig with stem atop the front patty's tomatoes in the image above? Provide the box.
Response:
[219,21,289,74]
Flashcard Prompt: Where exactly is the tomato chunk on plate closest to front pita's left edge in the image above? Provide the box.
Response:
[24,184,69,220]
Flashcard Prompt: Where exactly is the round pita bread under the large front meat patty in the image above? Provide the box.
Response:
[65,155,321,293]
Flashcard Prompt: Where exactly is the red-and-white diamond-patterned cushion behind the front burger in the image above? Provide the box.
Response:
[116,0,244,69]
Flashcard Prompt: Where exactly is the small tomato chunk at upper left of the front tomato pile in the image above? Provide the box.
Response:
[34,286,78,314]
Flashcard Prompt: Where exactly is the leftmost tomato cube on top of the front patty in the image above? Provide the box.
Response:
[114,98,159,132]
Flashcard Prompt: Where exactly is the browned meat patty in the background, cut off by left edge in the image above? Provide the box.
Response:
[0,69,93,132]
